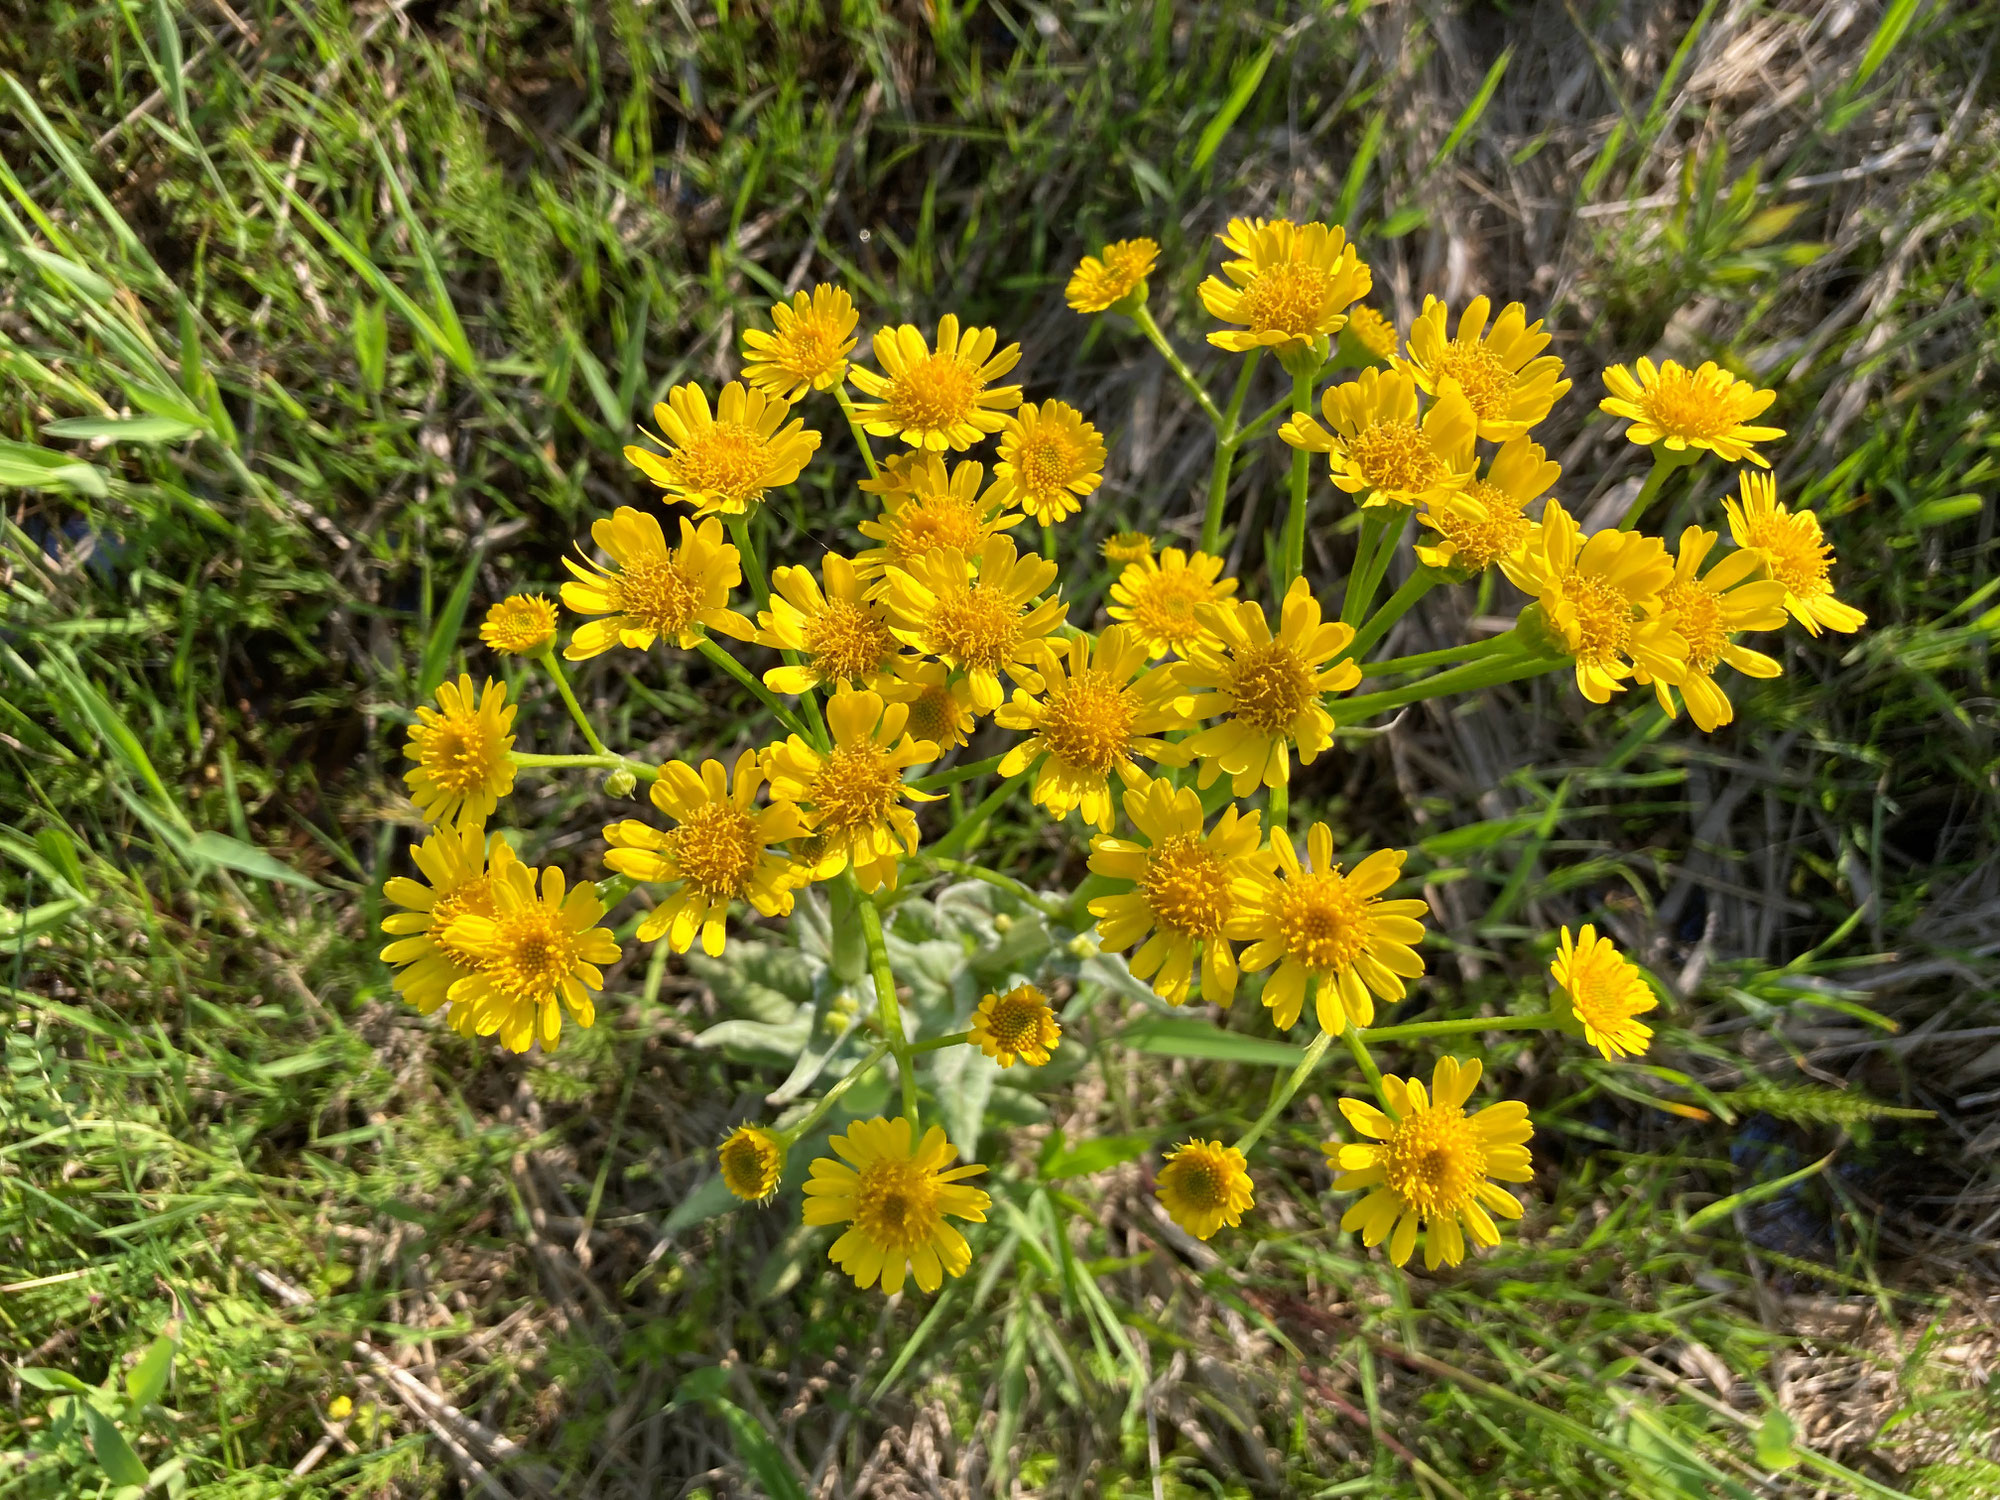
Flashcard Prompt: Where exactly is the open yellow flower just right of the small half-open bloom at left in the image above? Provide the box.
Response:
[562,506,756,662]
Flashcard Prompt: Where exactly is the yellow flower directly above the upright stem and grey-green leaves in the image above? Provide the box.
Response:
[764,692,938,890]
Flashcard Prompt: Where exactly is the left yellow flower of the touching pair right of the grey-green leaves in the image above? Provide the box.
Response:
[1090,776,1270,1006]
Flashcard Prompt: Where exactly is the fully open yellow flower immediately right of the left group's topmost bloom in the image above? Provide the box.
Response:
[848,312,1020,452]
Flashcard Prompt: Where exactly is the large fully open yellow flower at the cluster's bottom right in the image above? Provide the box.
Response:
[1320,1058,1534,1270]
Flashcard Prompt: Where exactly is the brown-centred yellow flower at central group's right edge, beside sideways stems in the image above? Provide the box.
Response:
[1176,578,1362,796]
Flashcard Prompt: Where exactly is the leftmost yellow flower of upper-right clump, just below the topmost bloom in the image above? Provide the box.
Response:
[1278,370,1478,506]
